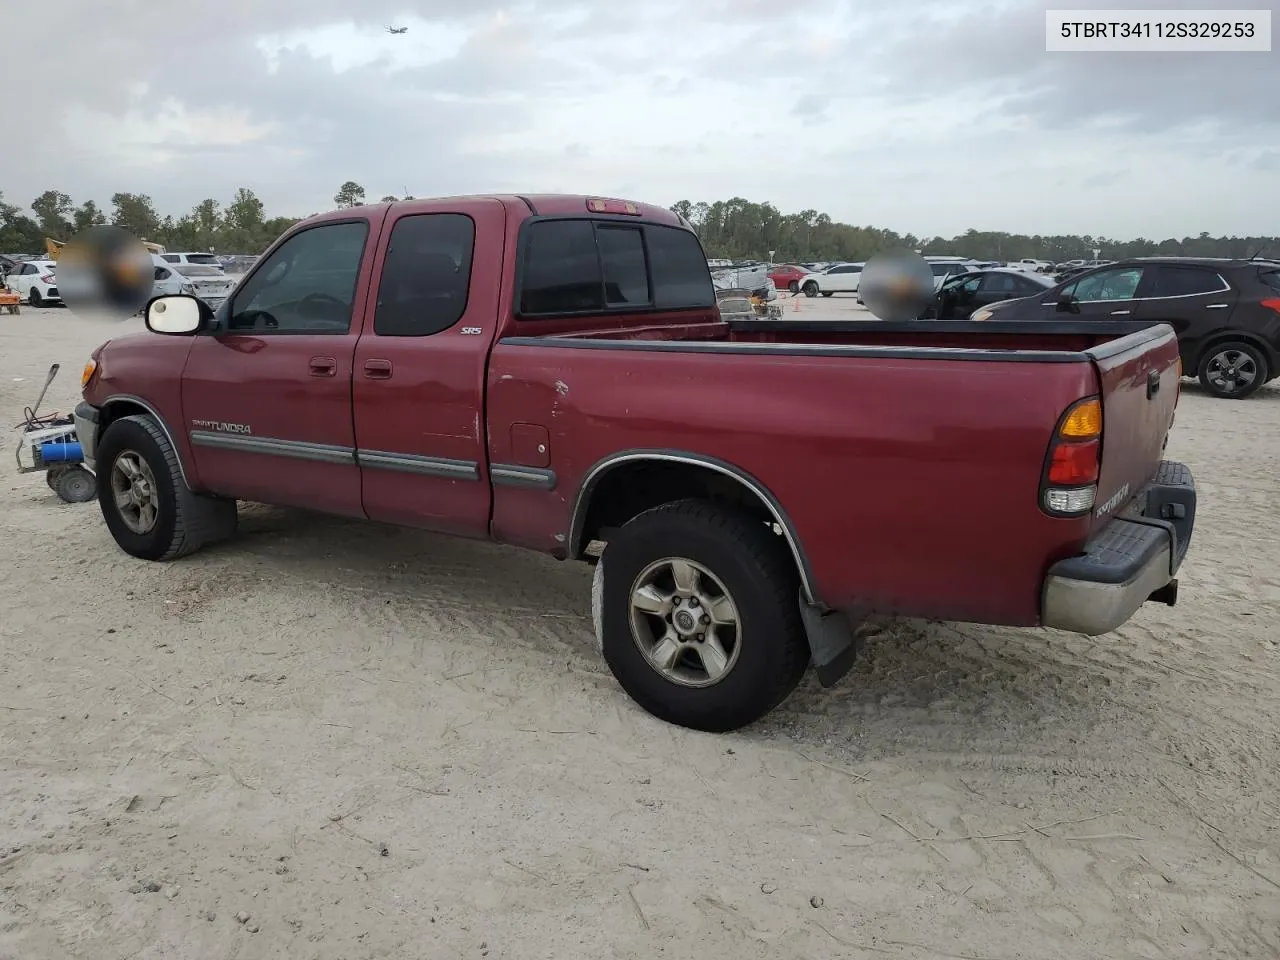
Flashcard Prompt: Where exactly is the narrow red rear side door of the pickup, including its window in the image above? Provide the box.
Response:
[353,200,506,536]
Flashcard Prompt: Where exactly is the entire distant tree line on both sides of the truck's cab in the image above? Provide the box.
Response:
[0,180,1280,262]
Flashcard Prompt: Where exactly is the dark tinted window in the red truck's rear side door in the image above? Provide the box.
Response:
[374,214,476,337]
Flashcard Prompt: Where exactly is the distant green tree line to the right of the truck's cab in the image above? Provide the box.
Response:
[671,197,1280,264]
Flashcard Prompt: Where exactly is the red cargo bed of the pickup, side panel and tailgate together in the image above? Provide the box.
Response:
[489,317,1178,625]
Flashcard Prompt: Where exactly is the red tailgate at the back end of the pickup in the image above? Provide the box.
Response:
[1087,324,1180,530]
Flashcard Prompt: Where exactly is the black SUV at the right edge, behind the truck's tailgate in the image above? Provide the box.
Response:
[973,257,1280,399]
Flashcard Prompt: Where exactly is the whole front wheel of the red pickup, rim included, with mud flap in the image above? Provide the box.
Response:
[96,415,237,561]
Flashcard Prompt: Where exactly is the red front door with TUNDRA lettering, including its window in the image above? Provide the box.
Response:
[182,211,383,516]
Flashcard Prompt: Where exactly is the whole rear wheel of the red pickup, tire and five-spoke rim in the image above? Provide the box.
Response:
[598,500,809,732]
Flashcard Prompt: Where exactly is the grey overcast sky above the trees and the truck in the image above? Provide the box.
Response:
[0,0,1280,238]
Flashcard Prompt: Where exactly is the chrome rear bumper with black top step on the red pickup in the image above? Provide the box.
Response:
[1041,460,1196,636]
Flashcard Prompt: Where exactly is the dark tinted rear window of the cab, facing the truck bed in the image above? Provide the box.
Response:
[518,219,716,317]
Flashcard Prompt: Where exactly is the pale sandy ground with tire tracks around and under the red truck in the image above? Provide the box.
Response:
[0,309,1280,960]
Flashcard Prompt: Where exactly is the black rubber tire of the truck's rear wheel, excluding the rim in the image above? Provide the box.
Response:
[600,500,810,733]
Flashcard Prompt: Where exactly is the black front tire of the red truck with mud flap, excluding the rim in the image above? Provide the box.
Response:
[95,415,237,561]
